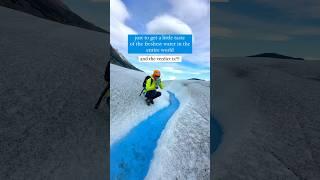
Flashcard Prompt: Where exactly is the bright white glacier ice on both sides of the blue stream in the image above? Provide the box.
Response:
[110,65,210,179]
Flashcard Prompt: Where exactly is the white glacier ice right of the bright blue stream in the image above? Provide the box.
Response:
[146,80,210,180]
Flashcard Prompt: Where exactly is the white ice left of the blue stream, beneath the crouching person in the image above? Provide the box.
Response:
[110,65,169,145]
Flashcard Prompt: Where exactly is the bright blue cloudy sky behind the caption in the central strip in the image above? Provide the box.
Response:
[110,0,210,80]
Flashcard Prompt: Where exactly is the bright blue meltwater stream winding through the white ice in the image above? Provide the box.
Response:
[110,92,180,180]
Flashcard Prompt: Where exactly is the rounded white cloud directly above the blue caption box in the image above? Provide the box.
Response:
[146,15,192,34]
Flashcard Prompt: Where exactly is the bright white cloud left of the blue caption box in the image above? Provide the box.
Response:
[110,0,137,49]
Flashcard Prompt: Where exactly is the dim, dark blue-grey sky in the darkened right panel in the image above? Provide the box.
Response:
[211,0,320,60]
